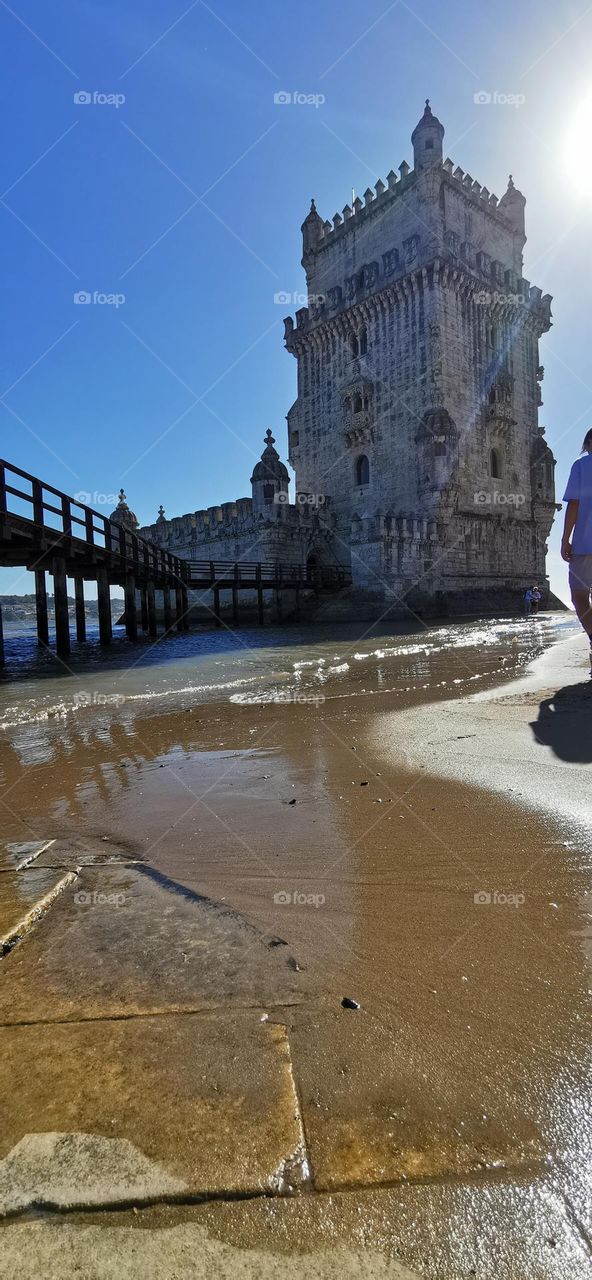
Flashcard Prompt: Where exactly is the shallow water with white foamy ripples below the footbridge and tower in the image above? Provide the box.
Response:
[0,613,575,746]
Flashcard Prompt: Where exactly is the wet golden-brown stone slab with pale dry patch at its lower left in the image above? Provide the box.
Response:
[0,1010,306,1215]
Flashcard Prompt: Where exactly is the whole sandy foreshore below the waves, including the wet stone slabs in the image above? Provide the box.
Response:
[0,616,592,1280]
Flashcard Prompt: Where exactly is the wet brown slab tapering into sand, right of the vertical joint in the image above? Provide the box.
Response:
[284,1009,548,1190]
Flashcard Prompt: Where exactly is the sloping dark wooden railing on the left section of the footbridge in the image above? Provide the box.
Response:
[0,460,186,582]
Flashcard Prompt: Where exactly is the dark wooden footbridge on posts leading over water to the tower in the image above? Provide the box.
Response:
[0,460,350,662]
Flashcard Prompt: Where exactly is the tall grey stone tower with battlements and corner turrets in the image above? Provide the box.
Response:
[284,102,555,609]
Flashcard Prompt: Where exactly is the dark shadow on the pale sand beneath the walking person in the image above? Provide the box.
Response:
[530,680,592,764]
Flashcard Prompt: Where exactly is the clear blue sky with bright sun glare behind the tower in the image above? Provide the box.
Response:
[0,0,592,595]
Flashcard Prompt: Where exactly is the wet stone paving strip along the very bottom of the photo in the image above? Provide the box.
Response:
[0,1178,591,1280]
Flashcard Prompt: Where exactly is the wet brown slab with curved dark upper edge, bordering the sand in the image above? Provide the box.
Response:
[0,864,306,1024]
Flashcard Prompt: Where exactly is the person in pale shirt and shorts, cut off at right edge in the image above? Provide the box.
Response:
[561,428,592,663]
